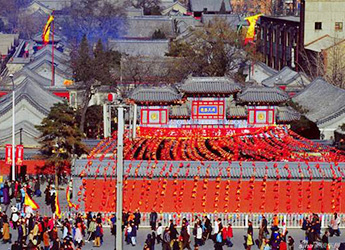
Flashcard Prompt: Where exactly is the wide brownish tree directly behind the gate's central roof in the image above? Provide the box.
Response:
[167,19,250,78]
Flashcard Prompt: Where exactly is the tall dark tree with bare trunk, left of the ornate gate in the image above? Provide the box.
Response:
[71,36,121,132]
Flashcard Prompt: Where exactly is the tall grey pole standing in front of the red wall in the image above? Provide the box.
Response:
[115,104,124,250]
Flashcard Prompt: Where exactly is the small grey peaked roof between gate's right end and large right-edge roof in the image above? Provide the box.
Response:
[262,66,310,88]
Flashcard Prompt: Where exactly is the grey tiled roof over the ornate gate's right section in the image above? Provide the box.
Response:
[237,85,289,103]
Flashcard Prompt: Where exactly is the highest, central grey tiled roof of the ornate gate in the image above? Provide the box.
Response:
[180,77,241,96]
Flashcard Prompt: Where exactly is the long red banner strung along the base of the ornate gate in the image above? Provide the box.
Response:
[138,127,267,138]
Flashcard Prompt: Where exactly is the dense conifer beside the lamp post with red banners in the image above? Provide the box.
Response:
[35,103,87,173]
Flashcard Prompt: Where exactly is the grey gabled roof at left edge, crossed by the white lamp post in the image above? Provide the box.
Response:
[0,78,61,116]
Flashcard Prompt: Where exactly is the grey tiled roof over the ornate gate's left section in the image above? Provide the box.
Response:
[129,86,181,103]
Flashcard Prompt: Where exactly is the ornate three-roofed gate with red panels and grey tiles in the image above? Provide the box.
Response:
[127,77,300,128]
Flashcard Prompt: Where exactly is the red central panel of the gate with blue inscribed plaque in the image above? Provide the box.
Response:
[192,101,225,120]
